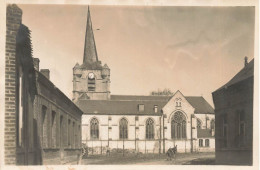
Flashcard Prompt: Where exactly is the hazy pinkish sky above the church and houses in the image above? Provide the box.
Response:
[18,5,255,107]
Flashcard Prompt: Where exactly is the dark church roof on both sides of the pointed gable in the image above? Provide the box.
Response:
[77,95,214,115]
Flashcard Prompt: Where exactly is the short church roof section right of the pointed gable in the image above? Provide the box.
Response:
[185,96,215,114]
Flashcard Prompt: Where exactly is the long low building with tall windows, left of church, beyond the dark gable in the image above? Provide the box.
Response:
[34,72,82,165]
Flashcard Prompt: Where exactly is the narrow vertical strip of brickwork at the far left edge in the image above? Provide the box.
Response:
[4,5,22,165]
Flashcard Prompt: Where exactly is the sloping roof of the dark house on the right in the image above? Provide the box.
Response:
[216,59,254,91]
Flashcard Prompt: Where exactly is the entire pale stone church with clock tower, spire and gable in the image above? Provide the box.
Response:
[73,9,215,154]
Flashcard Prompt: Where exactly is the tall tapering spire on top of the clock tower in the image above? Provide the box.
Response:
[83,6,98,64]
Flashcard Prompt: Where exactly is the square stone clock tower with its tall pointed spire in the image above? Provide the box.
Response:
[73,7,110,102]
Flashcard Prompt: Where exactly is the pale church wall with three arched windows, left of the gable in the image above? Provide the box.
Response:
[82,115,160,154]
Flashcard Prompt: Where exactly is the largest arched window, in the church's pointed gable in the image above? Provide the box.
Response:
[171,112,186,139]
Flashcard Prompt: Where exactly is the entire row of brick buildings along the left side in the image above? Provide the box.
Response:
[4,5,83,165]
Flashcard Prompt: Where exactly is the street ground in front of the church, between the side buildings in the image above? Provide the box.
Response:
[81,153,215,165]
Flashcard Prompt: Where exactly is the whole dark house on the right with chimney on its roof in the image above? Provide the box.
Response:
[212,57,254,165]
